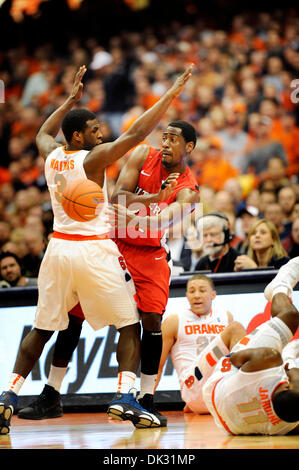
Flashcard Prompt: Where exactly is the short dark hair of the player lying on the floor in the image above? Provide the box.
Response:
[272,390,299,423]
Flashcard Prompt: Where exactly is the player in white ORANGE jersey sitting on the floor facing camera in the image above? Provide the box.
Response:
[157,274,246,413]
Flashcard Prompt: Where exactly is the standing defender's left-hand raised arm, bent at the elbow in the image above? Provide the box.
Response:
[36,65,86,158]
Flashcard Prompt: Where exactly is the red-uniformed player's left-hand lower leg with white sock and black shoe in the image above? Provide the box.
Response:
[18,315,84,419]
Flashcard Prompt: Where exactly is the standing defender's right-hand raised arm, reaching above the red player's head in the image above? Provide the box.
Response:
[84,65,193,175]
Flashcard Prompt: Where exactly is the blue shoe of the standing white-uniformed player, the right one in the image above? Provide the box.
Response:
[107,392,159,429]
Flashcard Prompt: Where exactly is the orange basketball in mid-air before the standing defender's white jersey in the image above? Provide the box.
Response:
[61,179,105,222]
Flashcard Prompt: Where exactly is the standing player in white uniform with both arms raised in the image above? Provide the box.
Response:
[0,66,192,434]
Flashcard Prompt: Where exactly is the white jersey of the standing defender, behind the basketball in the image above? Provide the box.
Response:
[45,147,109,236]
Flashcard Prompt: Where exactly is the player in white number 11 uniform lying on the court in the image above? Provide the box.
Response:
[203,289,299,435]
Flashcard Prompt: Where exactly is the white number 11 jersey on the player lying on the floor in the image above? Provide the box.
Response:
[210,361,298,435]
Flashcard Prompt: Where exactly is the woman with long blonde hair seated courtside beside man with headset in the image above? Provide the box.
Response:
[234,219,289,271]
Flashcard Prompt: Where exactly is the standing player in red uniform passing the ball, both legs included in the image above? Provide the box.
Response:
[15,121,199,427]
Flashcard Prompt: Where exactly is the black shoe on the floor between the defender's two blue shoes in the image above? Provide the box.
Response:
[18,385,63,419]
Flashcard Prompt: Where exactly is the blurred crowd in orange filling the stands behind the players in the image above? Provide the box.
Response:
[0,0,299,278]
